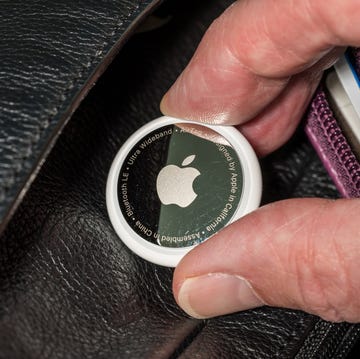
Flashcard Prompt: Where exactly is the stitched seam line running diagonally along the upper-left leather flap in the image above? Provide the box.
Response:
[0,0,143,198]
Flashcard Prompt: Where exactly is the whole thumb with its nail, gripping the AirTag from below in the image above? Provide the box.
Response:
[173,199,360,322]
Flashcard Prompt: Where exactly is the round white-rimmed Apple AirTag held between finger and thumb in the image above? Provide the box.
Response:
[106,116,262,267]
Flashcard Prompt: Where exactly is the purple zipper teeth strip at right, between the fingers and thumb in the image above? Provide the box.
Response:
[315,91,360,189]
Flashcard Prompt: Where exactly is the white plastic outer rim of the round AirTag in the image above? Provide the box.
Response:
[106,116,262,267]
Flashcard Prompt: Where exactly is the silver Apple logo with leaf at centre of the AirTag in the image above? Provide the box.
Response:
[156,155,200,208]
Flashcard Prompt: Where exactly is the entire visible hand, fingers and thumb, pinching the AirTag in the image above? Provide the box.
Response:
[161,0,360,322]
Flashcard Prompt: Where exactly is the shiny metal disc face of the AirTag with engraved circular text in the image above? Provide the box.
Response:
[118,123,243,247]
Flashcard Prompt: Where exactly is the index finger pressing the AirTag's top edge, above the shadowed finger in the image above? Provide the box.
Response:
[161,0,360,124]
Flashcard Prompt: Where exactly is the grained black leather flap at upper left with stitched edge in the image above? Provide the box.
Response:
[0,0,159,233]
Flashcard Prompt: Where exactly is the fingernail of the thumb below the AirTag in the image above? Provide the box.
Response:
[178,273,264,319]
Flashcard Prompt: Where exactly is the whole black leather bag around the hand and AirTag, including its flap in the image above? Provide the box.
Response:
[0,0,360,358]
